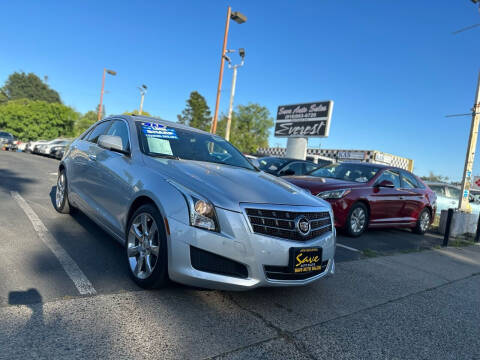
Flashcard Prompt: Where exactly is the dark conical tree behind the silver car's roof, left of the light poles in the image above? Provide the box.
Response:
[177,91,212,131]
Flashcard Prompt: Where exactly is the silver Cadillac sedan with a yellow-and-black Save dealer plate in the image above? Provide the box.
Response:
[55,116,335,290]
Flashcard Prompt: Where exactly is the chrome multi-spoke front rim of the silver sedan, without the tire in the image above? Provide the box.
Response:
[127,213,160,279]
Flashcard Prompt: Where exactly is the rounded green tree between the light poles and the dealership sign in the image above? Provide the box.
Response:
[218,103,273,154]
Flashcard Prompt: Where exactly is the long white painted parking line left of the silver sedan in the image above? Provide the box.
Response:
[10,191,97,295]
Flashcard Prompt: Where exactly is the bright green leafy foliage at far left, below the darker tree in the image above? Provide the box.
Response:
[0,99,79,140]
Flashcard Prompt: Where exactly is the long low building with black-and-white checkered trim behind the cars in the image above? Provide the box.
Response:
[257,147,413,171]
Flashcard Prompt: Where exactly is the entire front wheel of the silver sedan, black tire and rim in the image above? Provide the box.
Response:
[125,204,169,289]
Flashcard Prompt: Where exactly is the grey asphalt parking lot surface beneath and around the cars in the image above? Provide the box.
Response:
[0,152,480,359]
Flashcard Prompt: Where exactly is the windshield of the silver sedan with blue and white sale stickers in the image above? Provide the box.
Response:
[137,122,255,170]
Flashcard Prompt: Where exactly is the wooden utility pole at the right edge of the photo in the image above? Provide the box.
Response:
[458,73,480,212]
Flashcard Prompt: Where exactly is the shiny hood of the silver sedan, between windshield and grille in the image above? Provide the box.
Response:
[145,156,329,211]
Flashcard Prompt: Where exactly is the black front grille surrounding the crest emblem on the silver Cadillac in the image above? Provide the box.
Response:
[245,209,332,241]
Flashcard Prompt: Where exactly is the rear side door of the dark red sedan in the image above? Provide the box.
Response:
[400,171,427,222]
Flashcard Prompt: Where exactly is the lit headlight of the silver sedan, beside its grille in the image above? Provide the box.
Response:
[167,180,220,232]
